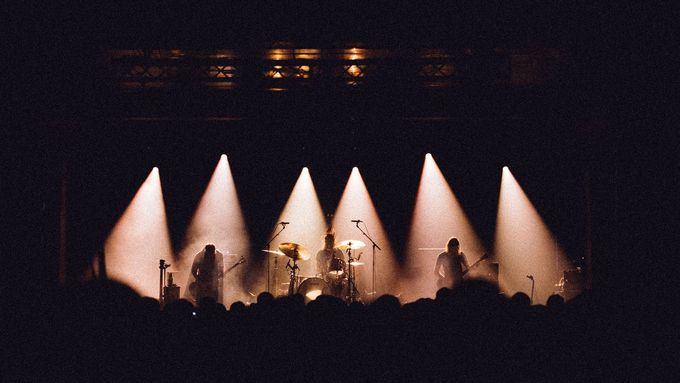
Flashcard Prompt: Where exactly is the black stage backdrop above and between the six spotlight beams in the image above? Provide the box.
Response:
[50,109,587,284]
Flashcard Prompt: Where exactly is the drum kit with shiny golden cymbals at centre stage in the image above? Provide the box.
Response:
[262,240,366,303]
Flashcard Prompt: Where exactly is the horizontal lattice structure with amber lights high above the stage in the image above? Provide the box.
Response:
[103,47,563,91]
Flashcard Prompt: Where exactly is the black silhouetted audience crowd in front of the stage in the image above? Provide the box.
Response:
[24,280,606,381]
